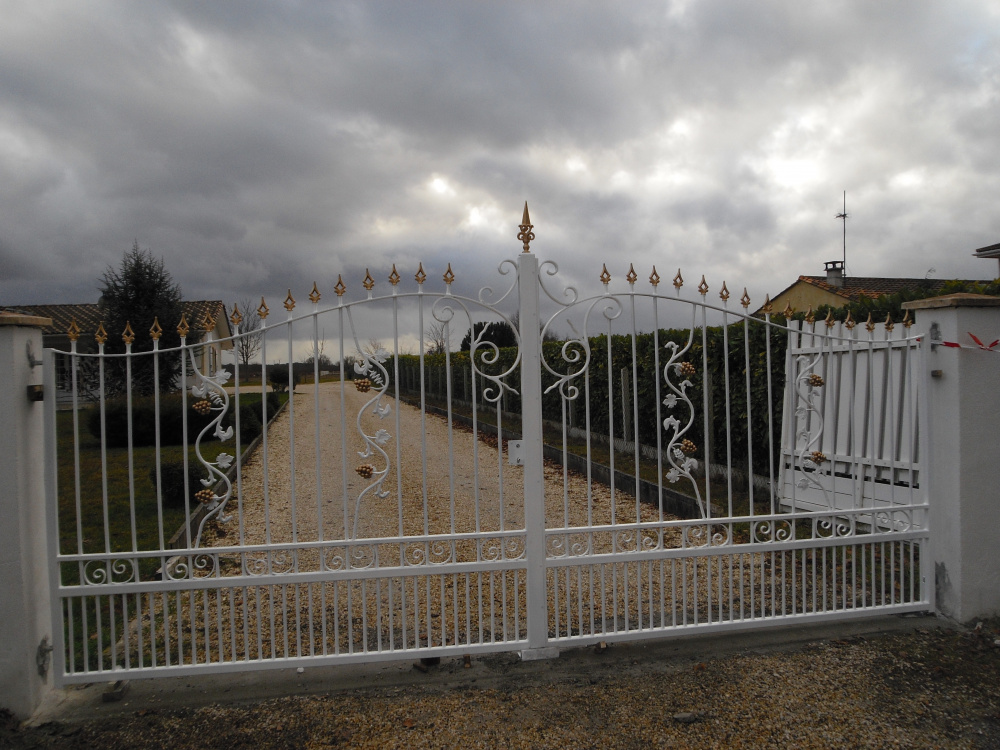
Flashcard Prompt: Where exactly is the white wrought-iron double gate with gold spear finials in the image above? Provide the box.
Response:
[39,223,931,683]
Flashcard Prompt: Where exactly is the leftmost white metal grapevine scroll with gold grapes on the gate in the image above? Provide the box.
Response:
[190,351,235,547]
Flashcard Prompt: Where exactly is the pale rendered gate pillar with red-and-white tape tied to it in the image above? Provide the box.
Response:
[903,294,1000,622]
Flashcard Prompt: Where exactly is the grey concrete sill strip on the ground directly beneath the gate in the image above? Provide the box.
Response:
[29,615,936,726]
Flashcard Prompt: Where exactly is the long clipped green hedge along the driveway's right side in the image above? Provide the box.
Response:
[387,322,787,474]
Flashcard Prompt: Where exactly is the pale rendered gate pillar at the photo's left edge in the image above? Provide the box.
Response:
[0,313,55,719]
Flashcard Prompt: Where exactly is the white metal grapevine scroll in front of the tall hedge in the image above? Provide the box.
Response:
[663,329,708,518]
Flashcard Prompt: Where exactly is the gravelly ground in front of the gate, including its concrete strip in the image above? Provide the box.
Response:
[19,616,1000,750]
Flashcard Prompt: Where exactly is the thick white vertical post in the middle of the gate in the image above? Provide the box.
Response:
[517,252,559,660]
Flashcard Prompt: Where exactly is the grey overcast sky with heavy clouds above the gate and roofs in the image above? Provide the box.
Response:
[0,0,1000,326]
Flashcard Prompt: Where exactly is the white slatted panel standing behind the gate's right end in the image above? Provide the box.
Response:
[781,321,923,525]
